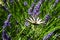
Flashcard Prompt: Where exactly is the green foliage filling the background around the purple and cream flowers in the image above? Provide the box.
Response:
[0,0,60,40]
